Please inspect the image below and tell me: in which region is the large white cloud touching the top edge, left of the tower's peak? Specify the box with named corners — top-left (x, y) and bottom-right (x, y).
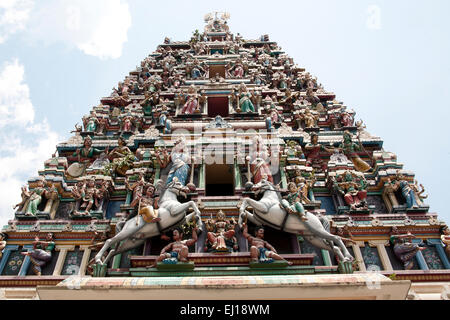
top-left (30, 0), bottom-right (131, 59)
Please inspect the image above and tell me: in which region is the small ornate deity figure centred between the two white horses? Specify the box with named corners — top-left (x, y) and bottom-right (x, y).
top-left (205, 210), bottom-right (238, 252)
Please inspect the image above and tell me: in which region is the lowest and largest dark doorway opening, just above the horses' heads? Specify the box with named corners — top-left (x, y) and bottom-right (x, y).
top-left (205, 164), bottom-right (234, 197)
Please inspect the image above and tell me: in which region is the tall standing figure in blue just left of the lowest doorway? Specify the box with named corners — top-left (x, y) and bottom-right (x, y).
top-left (166, 138), bottom-right (191, 186)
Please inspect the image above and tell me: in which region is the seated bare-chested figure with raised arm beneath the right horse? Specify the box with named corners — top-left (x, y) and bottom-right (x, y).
top-left (242, 223), bottom-right (292, 265)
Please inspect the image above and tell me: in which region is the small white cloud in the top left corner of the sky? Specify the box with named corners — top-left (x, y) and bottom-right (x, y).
top-left (0, 0), bottom-right (34, 44)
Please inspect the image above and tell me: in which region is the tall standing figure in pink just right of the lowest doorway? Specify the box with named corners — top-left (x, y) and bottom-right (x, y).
top-left (247, 135), bottom-right (274, 184)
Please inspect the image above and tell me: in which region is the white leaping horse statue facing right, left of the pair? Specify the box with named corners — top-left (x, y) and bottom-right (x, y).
top-left (95, 178), bottom-right (203, 265)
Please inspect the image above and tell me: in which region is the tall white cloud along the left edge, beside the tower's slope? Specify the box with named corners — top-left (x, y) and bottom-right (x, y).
top-left (0, 60), bottom-right (60, 227)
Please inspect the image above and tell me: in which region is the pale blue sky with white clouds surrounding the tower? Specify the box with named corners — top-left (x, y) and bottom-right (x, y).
top-left (0, 0), bottom-right (450, 225)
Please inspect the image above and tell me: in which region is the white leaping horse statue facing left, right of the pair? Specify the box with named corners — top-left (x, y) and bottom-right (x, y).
top-left (239, 179), bottom-right (353, 262)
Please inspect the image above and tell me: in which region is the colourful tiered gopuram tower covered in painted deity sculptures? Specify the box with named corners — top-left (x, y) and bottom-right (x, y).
top-left (0, 12), bottom-right (450, 300)
